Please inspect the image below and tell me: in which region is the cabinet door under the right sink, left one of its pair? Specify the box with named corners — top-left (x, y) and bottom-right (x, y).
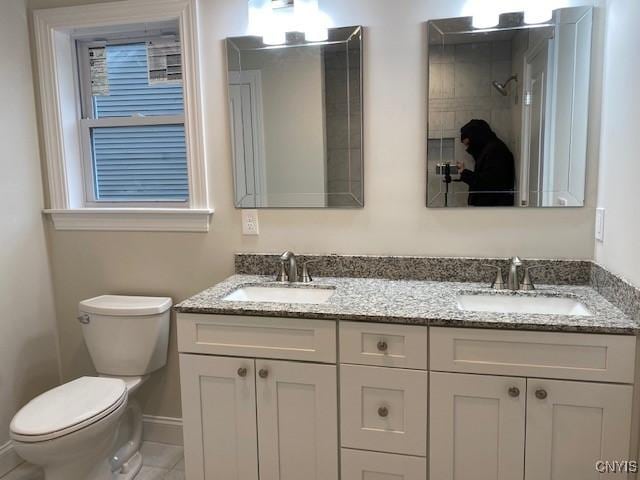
top-left (429, 372), bottom-right (526, 480)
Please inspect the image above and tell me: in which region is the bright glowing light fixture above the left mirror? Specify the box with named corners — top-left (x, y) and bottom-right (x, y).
top-left (248, 0), bottom-right (331, 45)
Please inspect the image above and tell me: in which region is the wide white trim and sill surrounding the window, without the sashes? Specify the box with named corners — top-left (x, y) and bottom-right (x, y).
top-left (33, 0), bottom-right (213, 232)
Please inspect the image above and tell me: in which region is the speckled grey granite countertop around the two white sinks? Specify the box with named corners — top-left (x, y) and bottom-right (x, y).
top-left (175, 275), bottom-right (640, 335)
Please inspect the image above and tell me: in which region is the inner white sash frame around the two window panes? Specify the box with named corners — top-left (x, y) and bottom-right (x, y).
top-left (76, 36), bottom-right (191, 208)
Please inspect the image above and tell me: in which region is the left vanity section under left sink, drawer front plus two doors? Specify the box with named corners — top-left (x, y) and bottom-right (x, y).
top-left (178, 314), bottom-right (339, 480)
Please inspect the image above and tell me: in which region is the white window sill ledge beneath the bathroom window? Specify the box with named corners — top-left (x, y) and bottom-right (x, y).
top-left (44, 208), bottom-right (213, 232)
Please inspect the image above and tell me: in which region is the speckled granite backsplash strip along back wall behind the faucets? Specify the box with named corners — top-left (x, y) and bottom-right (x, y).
top-left (235, 253), bottom-right (592, 285)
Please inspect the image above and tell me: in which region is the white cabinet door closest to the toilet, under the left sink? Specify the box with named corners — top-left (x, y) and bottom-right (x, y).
top-left (180, 354), bottom-right (258, 480)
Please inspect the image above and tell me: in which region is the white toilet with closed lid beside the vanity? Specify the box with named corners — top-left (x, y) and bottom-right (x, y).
top-left (10, 295), bottom-right (172, 480)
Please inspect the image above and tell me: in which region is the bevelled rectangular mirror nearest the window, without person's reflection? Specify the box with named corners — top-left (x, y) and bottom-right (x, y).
top-left (227, 27), bottom-right (364, 208)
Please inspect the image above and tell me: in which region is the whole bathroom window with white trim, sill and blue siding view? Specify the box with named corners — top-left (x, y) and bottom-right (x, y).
top-left (34, 0), bottom-right (213, 232)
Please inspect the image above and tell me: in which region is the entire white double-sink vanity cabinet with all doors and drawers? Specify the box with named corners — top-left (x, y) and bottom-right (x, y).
top-left (178, 313), bottom-right (640, 480)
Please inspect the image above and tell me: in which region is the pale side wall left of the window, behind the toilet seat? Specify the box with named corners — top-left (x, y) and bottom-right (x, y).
top-left (0, 0), bottom-right (59, 458)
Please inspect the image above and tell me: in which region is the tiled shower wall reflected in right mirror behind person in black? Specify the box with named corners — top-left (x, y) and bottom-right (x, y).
top-left (428, 41), bottom-right (516, 206)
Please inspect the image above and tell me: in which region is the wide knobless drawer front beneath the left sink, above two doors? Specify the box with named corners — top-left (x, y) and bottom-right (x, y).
top-left (178, 313), bottom-right (336, 363)
